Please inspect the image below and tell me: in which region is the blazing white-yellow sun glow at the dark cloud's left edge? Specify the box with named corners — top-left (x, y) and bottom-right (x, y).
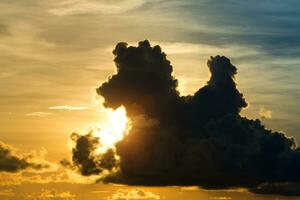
top-left (94, 106), bottom-right (130, 153)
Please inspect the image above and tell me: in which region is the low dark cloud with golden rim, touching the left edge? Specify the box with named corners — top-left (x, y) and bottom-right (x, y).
top-left (0, 142), bottom-right (49, 172)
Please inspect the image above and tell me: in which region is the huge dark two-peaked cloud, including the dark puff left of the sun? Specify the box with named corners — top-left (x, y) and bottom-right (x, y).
top-left (69, 41), bottom-right (300, 192)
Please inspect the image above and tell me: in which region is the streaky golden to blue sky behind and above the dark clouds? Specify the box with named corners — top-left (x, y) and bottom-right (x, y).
top-left (0, 0), bottom-right (300, 199)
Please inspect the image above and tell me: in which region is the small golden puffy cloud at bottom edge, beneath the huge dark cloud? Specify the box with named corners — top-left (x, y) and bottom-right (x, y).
top-left (108, 189), bottom-right (160, 200)
